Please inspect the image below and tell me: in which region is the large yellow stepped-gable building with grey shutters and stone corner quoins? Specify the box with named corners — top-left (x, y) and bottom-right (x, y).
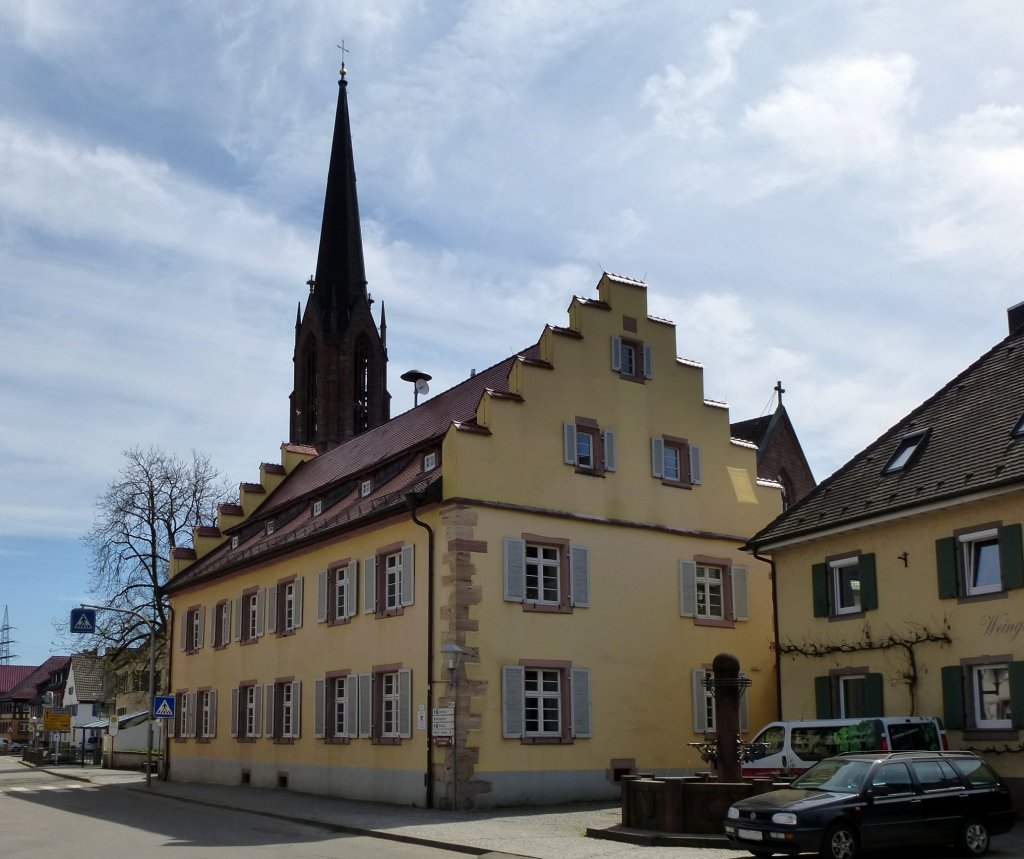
top-left (161, 274), bottom-right (781, 807)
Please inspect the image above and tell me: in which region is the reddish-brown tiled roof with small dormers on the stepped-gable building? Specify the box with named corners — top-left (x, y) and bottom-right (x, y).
top-left (165, 345), bottom-right (545, 592)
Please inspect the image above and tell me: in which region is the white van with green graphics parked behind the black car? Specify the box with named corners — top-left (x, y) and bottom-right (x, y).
top-left (741, 716), bottom-right (947, 778)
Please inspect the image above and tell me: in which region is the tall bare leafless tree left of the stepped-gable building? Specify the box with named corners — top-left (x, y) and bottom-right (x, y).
top-left (83, 446), bottom-right (233, 655)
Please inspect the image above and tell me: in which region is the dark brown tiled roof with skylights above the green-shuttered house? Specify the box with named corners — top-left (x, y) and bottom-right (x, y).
top-left (749, 328), bottom-right (1024, 550)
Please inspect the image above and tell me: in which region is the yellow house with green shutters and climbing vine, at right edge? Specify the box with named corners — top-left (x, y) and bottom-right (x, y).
top-left (748, 305), bottom-right (1024, 798)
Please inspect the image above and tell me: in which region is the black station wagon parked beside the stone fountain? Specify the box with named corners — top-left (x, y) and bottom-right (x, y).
top-left (725, 751), bottom-right (1017, 859)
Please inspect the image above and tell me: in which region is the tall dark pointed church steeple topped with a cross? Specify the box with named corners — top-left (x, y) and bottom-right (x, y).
top-left (289, 65), bottom-right (390, 453)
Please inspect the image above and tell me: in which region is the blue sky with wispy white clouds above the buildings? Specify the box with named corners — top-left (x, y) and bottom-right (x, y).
top-left (0, 0), bottom-right (1024, 664)
